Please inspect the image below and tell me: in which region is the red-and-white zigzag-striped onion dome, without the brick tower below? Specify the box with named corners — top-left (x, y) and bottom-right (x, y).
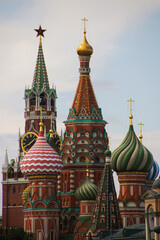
top-left (21, 125), bottom-right (63, 176)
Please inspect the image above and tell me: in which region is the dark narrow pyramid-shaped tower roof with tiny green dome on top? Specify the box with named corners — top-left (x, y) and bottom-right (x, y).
top-left (87, 148), bottom-right (122, 239)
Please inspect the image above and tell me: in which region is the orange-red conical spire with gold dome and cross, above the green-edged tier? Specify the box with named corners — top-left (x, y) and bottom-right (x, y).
top-left (68, 18), bottom-right (103, 120)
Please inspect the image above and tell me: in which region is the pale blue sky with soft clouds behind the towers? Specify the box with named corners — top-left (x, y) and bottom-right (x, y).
top-left (0, 0), bottom-right (160, 216)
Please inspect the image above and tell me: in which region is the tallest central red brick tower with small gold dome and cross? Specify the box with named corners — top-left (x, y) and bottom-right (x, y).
top-left (58, 19), bottom-right (107, 232)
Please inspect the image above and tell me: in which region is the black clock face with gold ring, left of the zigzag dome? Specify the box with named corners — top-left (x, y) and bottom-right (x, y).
top-left (21, 132), bottom-right (38, 153)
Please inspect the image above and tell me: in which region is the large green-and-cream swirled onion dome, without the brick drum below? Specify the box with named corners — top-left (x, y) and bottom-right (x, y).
top-left (111, 125), bottom-right (153, 172)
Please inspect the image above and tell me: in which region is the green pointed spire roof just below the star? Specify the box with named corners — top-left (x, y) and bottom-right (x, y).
top-left (32, 41), bottom-right (50, 95)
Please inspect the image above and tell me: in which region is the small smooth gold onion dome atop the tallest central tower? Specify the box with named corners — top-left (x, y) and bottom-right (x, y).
top-left (77, 32), bottom-right (93, 56)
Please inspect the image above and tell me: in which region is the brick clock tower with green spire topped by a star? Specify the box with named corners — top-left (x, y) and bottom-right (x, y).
top-left (2, 26), bottom-right (57, 229)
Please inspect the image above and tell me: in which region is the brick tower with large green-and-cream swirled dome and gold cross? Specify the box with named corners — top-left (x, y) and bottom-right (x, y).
top-left (111, 99), bottom-right (153, 227)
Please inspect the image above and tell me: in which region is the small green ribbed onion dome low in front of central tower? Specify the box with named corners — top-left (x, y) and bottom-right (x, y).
top-left (75, 172), bottom-right (98, 201)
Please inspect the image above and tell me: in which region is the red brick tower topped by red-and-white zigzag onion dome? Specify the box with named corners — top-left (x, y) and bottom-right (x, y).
top-left (21, 122), bottom-right (63, 240)
